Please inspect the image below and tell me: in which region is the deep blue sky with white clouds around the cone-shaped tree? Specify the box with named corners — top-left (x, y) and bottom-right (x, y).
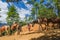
top-left (0, 0), bottom-right (32, 22)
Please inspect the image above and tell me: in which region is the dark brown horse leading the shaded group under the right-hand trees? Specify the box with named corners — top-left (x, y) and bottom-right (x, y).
top-left (32, 18), bottom-right (47, 31)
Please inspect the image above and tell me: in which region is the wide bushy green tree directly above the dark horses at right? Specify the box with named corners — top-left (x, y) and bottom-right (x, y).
top-left (38, 0), bottom-right (57, 18)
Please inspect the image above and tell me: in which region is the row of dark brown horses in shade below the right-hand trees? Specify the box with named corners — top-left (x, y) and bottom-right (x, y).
top-left (32, 17), bottom-right (60, 30)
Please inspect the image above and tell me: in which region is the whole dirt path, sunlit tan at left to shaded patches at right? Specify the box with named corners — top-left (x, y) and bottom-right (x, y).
top-left (0, 30), bottom-right (60, 40)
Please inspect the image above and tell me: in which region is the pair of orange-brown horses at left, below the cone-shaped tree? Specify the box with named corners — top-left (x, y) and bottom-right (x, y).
top-left (0, 22), bottom-right (20, 36)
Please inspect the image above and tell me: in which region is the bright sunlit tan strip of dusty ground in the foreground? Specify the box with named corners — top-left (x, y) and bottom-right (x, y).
top-left (0, 33), bottom-right (44, 40)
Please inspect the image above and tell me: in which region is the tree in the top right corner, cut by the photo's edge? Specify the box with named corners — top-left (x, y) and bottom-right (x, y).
top-left (47, 0), bottom-right (60, 17)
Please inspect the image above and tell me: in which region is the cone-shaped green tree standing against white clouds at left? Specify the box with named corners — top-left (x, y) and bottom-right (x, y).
top-left (6, 5), bottom-right (19, 25)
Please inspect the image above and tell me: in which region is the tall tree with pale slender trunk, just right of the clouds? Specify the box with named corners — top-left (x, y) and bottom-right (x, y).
top-left (27, 0), bottom-right (39, 20)
